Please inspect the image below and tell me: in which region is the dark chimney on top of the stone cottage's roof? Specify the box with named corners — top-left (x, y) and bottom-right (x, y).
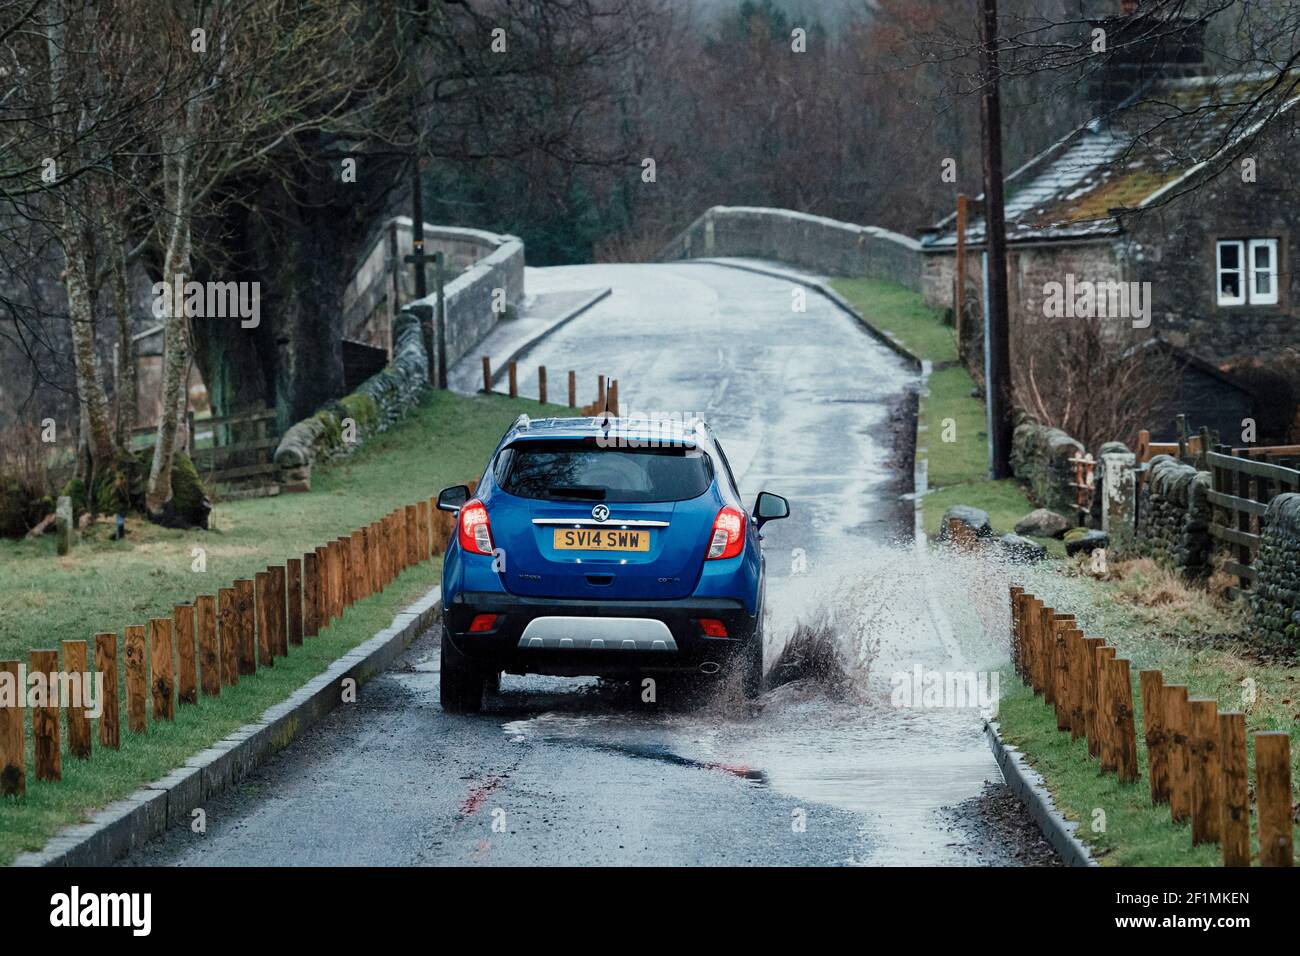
top-left (1088, 0), bottom-right (1205, 112)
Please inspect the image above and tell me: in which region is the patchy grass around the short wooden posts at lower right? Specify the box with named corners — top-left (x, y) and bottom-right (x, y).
top-left (998, 561), bottom-right (1300, 866)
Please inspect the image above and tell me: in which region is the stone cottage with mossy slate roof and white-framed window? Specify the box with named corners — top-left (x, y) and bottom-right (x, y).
top-left (922, 43), bottom-right (1300, 444)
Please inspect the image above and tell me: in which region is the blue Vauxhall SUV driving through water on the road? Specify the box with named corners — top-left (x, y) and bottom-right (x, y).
top-left (438, 415), bottom-right (789, 713)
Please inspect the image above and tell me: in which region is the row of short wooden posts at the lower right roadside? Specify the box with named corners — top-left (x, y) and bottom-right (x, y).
top-left (1011, 585), bottom-right (1294, 866)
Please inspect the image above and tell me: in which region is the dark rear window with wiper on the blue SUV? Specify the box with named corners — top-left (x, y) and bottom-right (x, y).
top-left (495, 441), bottom-right (714, 502)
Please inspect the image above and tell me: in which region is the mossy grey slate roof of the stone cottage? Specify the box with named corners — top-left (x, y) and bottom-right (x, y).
top-left (922, 73), bottom-right (1300, 251)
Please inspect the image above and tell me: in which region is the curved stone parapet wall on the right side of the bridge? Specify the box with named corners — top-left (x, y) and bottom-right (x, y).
top-left (658, 206), bottom-right (922, 291)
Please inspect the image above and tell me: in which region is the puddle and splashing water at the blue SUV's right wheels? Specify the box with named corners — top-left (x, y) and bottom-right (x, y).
top-left (493, 548), bottom-right (1024, 865)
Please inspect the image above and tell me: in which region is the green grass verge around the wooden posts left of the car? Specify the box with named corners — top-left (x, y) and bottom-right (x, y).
top-left (0, 393), bottom-right (567, 865)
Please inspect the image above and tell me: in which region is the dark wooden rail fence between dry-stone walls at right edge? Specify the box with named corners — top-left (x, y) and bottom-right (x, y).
top-left (1205, 445), bottom-right (1300, 597)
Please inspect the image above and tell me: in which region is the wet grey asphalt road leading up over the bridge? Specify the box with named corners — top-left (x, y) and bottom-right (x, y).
top-left (129, 264), bottom-right (1034, 865)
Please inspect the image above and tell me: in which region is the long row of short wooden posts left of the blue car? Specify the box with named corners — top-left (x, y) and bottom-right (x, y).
top-left (0, 481), bottom-right (477, 797)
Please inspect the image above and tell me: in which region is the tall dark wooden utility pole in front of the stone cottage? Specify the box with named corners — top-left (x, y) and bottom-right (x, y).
top-left (980, 0), bottom-right (1014, 479)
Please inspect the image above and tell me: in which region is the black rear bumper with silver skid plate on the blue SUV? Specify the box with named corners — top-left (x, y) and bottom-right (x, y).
top-left (443, 592), bottom-right (758, 676)
